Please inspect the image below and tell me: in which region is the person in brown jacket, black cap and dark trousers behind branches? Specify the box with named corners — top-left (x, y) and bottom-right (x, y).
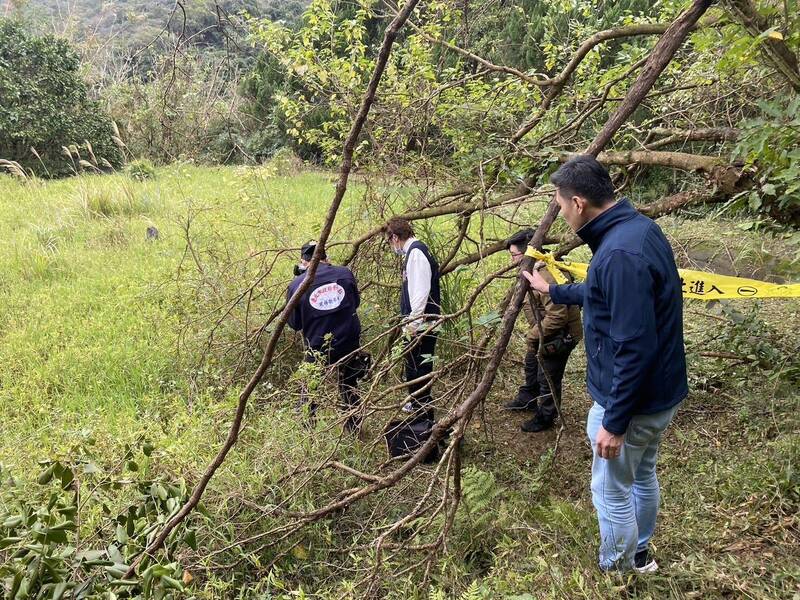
top-left (505, 229), bottom-right (583, 433)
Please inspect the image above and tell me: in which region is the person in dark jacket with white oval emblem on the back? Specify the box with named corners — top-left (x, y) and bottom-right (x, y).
top-left (287, 242), bottom-right (361, 431)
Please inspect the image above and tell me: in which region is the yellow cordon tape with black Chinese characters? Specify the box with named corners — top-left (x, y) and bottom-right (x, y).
top-left (525, 247), bottom-right (800, 300)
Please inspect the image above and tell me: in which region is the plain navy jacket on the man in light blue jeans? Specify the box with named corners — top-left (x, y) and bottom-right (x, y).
top-left (550, 199), bottom-right (689, 435)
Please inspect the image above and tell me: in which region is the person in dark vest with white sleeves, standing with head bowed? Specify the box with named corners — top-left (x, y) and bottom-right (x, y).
top-left (384, 218), bottom-right (442, 421)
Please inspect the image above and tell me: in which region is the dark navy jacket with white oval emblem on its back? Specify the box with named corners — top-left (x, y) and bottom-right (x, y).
top-left (286, 263), bottom-right (361, 355)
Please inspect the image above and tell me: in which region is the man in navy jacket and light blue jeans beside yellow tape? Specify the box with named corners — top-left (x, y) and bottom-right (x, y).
top-left (523, 156), bottom-right (688, 572)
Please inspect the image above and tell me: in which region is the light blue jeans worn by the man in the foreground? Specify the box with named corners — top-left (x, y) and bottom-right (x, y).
top-left (586, 402), bottom-right (680, 571)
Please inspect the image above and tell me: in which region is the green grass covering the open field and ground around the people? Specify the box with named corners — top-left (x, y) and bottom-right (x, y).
top-left (0, 166), bottom-right (800, 598)
